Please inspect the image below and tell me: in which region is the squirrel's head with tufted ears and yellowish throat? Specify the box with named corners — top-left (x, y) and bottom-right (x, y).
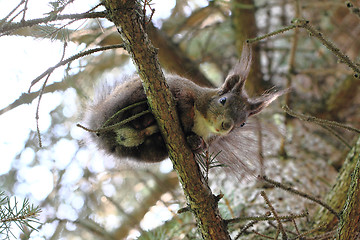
top-left (195, 46), bottom-right (287, 139)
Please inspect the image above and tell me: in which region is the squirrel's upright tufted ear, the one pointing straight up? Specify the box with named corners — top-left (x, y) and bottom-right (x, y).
top-left (220, 44), bottom-right (252, 93)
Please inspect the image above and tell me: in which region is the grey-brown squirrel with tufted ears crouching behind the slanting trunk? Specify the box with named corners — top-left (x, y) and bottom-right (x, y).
top-left (82, 47), bottom-right (286, 162)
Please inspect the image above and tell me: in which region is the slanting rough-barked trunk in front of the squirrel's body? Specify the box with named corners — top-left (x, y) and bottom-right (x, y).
top-left (105, 0), bottom-right (230, 239)
